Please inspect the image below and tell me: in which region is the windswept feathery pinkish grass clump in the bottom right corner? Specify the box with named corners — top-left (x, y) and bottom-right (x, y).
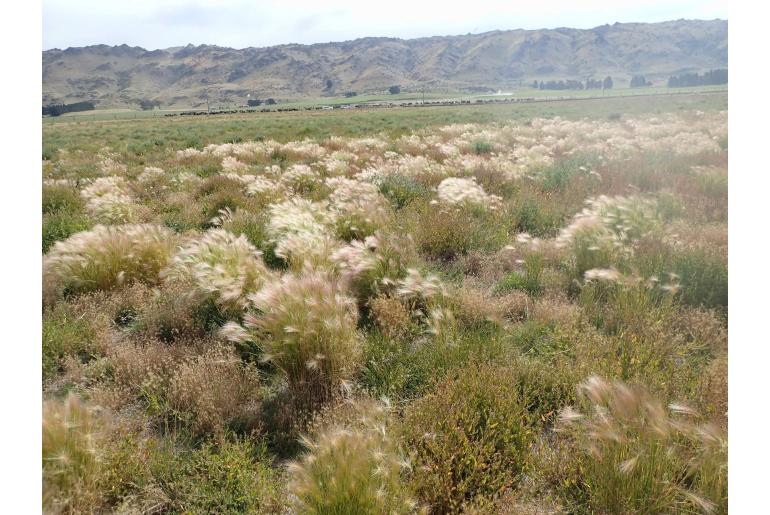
top-left (560, 377), bottom-right (727, 514)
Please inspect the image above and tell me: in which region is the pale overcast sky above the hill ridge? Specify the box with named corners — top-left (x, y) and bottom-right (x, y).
top-left (43, 0), bottom-right (727, 50)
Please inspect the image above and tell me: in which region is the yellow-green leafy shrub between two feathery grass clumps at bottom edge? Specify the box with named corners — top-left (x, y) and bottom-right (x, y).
top-left (403, 365), bottom-right (531, 513)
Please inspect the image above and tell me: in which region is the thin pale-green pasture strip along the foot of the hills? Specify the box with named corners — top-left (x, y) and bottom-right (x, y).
top-left (43, 86), bottom-right (727, 123)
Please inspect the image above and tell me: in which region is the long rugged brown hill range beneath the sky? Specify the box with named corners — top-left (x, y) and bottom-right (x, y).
top-left (42, 20), bottom-right (727, 107)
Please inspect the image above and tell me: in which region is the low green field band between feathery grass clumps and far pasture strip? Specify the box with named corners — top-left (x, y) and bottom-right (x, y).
top-left (43, 91), bottom-right (727, 161)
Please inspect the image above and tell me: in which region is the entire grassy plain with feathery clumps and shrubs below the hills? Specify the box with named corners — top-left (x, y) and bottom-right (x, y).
top-left (41, 90), bottom-right (729, 515)
